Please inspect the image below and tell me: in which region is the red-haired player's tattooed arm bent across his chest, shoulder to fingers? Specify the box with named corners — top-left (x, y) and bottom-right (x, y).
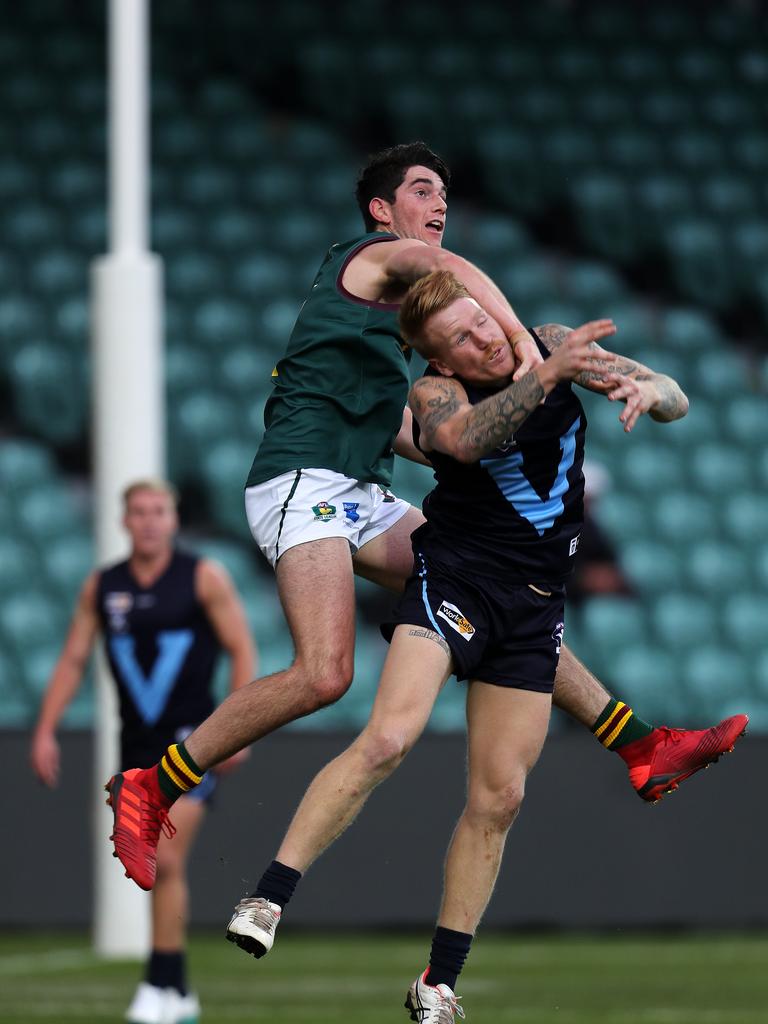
top-left (409, 321), bottom-right (616, 462)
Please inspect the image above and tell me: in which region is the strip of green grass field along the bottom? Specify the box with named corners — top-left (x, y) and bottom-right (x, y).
top-left (0, 932), bottom-right (768, 1024)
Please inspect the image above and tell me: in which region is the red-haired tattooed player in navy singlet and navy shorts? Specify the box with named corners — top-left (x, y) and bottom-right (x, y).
top-left (227, 271), bottom-right (746, 1024)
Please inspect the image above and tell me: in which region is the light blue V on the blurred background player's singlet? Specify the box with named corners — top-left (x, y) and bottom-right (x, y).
top-left (110, 630), bottom-right (195, 725)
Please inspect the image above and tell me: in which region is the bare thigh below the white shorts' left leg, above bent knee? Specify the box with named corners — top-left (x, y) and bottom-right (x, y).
top-left (275, 537), bottom-right (354, 658)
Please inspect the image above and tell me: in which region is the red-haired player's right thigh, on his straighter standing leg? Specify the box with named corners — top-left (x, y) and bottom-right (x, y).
top-left (467, 680), bottom-right (552, 792)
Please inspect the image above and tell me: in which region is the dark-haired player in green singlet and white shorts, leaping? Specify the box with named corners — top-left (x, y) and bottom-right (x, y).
top-left (110, 142), bottom-right (749, 905)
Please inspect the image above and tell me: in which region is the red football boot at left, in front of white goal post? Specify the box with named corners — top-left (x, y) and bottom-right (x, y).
top-left (104, 768), bottom-right (176, 890)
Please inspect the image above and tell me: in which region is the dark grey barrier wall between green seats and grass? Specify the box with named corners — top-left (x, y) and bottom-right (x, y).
top-left (0, 732), bottom-right (768, 928)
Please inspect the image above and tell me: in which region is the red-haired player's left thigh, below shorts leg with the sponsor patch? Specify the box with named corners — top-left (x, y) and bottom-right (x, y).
top-left (367, 625), bottom-right (452, 743)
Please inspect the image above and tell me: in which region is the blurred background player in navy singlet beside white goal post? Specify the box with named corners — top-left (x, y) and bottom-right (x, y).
top-left (32, 480), bottom-right (255, 1024)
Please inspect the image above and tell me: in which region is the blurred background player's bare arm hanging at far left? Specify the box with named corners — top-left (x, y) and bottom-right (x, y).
top-left (30, 572), bottom-right (98, 786)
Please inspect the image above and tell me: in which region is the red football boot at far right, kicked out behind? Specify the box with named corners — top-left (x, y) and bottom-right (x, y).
top-left (616, 715), bottom-right (750, 804)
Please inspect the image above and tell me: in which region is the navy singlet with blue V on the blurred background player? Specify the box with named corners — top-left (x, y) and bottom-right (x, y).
top-left (96, 551), bottom-right (220, 754)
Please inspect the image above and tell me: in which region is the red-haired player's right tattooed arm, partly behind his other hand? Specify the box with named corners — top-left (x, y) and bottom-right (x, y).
top-left (536, 324), bottom-right (688, 433)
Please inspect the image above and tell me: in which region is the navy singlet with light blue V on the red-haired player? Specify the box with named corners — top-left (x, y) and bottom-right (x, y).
top-left (414, 338), bottom-right (587, 583)
